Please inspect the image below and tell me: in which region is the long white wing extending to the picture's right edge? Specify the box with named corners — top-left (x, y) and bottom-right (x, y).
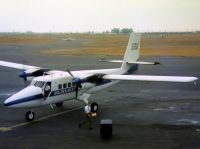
top-left (102, 75), bottom-right (198, 82)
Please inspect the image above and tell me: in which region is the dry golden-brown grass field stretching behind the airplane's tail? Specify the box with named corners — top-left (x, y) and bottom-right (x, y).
top-left (0, 33), bottom-right (200, 56)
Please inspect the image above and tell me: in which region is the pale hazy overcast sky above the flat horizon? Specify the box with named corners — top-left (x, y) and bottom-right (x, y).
top-left (0, 0), bottom-right (200, 32)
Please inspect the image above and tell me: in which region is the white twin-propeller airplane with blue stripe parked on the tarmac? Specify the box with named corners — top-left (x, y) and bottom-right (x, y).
top-left (0, 33), bottom-right (198, 121)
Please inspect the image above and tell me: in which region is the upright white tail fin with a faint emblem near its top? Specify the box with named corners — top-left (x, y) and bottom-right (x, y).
top-left (121, 32), bottom-right (140, 71)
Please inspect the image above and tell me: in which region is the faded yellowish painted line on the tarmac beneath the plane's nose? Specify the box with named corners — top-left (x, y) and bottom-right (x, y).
top-left (0, 106), bottom-right (83, 132)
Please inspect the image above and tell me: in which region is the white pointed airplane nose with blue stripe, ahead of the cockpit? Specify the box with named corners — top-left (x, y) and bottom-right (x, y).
top-left (4, 86), bottom-right (43, 107)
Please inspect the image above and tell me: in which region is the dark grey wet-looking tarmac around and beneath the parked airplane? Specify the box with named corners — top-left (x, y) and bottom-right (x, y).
top-left (0, 41), bottom-right (200, 149)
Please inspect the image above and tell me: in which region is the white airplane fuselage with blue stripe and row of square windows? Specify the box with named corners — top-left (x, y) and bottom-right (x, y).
top-left (4, 69), bottom-right (121, 108)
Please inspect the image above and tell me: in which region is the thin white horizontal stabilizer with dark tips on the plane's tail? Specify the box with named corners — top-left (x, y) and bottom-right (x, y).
top-left (99, 59), bottom-right (160, 65)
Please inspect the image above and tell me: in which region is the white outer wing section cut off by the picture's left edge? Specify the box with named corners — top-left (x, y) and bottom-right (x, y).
top-left (0, 61), bottom-right (40, 70)
